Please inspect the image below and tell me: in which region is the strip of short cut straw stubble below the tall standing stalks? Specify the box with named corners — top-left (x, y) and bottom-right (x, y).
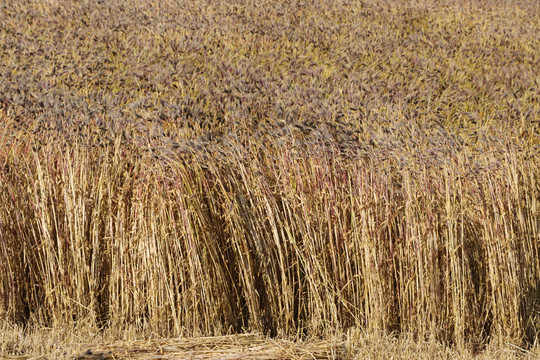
top-left (2, 326), bottom-right (540, 360)
